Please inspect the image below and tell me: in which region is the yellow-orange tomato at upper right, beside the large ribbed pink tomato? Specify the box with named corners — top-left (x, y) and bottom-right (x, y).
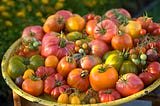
top-left (119, 20), bottom-right (142, 39)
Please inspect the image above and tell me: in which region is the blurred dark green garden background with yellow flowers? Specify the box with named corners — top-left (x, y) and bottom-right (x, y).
top-left (0, 0), bottom-right (160, 102)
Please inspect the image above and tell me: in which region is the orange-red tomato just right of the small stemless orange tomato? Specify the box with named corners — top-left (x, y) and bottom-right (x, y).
top-left (57, 56), bottom-right (77, 77)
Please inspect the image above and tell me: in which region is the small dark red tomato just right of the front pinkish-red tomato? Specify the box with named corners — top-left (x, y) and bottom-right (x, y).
top-left (139, 72), bottom-right (156, 85)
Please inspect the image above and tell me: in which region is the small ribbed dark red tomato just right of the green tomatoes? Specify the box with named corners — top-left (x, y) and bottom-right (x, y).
top-left (35, 66), bottom-right (56, 79)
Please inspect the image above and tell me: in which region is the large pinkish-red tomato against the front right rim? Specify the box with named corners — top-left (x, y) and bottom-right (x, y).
top-left (116, 73), bottom-right (144, 97)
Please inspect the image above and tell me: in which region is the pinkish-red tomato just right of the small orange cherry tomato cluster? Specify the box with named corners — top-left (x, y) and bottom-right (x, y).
top-left (89, 39), bottom-right (109, 57)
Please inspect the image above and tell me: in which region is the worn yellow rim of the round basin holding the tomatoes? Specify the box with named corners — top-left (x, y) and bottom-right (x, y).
top-left (1, 38), bottom-right (160, 106)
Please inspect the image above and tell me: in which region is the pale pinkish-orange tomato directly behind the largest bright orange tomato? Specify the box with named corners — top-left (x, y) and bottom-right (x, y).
top-left (80, 55), bottom-right (102, 71)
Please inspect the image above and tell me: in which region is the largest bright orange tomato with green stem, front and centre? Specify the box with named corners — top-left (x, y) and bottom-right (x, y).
top-left (89, 64), bottom-right (118, 91)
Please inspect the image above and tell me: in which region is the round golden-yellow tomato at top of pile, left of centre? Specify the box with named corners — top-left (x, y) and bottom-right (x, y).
top-left (65, 15), bottom-right (85, 32)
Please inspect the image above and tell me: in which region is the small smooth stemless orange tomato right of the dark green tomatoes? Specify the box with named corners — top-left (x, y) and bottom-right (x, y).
top-left (45, 55), bottom-right (59, 68)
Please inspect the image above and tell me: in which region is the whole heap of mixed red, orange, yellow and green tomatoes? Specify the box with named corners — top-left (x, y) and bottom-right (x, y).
top-left (7, 8), bottom-right (160, 104)
